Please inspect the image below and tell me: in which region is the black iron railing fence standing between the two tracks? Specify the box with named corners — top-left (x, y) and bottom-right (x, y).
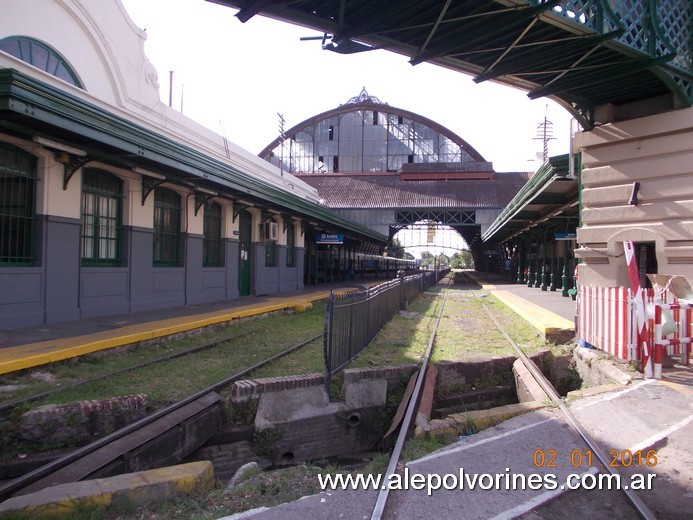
top-left (323, 269), bottom-right (449, 390)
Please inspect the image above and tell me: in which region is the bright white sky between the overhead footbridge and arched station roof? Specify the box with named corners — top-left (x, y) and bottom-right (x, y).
top-left (121, 0), bottom-right (571, 171)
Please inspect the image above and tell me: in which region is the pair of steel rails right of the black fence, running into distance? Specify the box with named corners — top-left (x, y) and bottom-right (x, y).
top-left (371, 273), bottom-right (656, 520)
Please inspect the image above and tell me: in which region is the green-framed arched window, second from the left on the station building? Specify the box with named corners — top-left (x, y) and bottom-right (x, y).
top-left (81, 168), bottom-right (123, 267)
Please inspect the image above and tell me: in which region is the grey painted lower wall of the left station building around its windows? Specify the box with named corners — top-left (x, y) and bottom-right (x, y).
top-left (0, 229), bottom-right (305, 328)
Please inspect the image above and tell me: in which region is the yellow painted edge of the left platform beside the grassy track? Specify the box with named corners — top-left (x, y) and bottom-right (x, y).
top-left (0, 291), bottom-right (330, 374)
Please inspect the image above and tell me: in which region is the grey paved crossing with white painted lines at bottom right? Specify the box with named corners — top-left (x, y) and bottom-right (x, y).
top-left (224, 370), bottom-right (693, 520)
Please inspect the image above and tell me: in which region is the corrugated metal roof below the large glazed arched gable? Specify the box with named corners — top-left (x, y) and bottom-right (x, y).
top-left (297, 172), bottom-right (532, 209)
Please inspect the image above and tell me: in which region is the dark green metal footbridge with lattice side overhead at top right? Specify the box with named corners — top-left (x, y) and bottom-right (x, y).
top-left (209, 0), bottom-right (693, 128)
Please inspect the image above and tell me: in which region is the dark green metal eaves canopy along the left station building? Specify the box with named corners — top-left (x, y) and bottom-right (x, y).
top-left (0, 69), bottom-right (387, 244)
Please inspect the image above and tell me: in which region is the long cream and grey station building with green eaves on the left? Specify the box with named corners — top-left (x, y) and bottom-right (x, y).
top-left (0, 0), bottom-right (387, 328)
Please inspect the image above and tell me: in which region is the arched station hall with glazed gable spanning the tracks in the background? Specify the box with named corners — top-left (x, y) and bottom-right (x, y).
top-left (259, 87), bottom-right (531, 266)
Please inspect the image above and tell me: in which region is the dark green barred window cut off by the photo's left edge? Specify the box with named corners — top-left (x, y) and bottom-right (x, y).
top-left (0, 143), bottom-right (36, 267)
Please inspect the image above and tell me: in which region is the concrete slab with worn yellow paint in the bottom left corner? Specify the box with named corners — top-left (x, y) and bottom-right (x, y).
top-left (0, 461), bottom-right (214, 517)
